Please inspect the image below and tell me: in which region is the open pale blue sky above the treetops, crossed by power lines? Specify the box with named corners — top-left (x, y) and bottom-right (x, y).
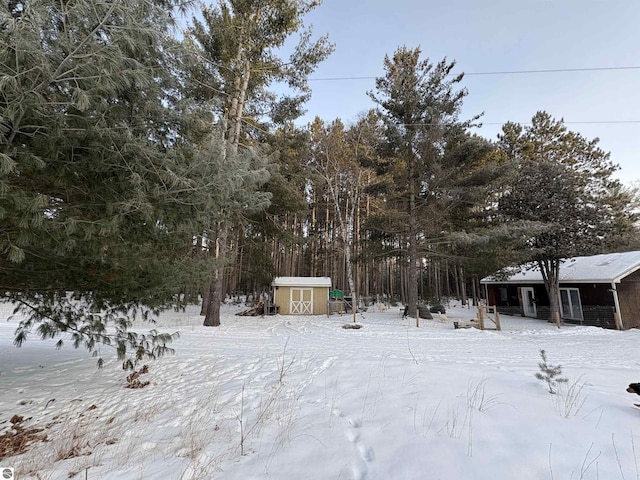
top-left (300, 0), bottom-right (640, 185)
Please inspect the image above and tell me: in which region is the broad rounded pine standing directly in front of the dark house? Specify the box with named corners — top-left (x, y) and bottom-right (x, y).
top-left (497, 112), bottom-right (636, 326)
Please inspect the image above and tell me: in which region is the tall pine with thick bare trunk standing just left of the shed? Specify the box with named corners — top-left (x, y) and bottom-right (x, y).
top-left (187, 0), bottom-right (333, 326)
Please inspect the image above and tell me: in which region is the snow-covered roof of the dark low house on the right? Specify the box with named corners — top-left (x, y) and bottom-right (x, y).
top-left (480, 251), bottom-right (640, 283)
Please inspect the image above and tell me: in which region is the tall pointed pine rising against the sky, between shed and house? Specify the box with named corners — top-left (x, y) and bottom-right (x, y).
top-left (369, 48), bottom-right (478, 317)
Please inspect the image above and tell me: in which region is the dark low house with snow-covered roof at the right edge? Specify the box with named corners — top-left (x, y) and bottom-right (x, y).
top-left (480, 252), bottom-right (640, 329)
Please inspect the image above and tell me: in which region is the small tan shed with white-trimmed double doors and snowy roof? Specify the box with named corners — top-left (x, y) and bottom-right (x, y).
top-left (271, 277), bottom-right (331, 315)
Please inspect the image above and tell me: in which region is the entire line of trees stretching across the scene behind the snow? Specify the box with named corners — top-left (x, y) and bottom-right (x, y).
top-left (0, 0), bottom-right (637, 360)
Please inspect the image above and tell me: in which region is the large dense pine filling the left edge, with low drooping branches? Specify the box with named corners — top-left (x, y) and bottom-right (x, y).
top-left (0, 0), bottom-right (226, 364)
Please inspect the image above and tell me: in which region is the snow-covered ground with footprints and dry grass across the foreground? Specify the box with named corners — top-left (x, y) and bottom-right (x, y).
top-left (0, 306), bottom-right (640, 480)
